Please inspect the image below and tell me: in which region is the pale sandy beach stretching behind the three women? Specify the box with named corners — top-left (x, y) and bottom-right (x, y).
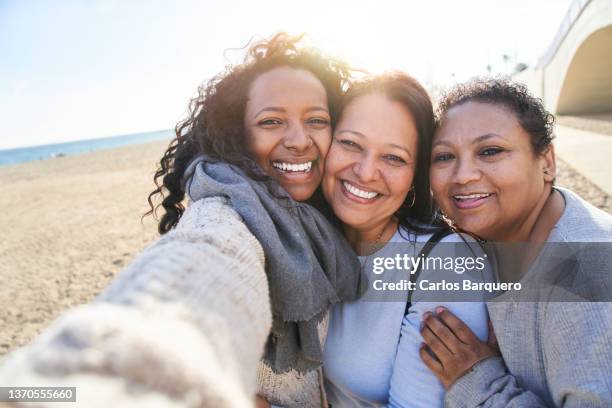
top-left (0, 142), bottom-right (612, 355)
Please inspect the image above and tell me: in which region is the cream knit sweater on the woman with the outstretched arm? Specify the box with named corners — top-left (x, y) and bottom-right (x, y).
top-left (0, 198), bottom-right (325, 408)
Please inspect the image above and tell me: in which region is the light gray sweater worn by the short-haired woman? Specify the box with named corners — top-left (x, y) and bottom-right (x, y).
top-left (446, 189), bottom-right (612, 408)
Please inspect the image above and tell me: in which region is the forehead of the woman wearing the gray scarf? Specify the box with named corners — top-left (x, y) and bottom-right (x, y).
top-left (247, 66), bottom-right (327, 108)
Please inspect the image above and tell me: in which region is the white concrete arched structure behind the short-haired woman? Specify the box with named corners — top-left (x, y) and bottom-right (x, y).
top-left (514, 0), bottom-right (612, 115)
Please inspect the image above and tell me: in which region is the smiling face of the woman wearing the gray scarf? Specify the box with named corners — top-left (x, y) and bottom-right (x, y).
top-left (244, 67), bottom-right (331, 201)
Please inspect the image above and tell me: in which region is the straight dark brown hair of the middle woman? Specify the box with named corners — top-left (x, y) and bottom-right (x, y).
top-left (342, 71), bottom-right (436, 232)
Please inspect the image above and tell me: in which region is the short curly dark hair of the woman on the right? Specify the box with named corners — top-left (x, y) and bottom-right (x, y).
top-left (437, 78), bottom-right (555, 153)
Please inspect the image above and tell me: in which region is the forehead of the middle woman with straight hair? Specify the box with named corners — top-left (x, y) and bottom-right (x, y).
top-left (337, 93), bottom-right (417, 145)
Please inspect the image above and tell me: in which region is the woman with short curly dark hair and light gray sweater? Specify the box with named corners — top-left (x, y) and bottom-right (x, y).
top-left (421, 79), bottom-right (612, 407)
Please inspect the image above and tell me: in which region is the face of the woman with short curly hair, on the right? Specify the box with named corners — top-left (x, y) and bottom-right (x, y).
top-left (430, 102), bottom-right (554, 241)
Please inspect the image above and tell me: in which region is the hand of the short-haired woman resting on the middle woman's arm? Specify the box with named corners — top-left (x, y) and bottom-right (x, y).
top-left (419, 307), bottom-right (501, 390)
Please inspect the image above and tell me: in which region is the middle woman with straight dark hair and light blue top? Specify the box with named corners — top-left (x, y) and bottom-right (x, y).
top-left (323, 72), bottom-right (486, 408)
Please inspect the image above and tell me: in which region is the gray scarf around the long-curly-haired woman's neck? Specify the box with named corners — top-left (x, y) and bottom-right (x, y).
top-left (184, 156), bottom-right (363, 373)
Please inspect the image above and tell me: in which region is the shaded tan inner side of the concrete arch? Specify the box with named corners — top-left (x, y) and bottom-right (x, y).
top-left (556, 25), bottom-right (612, 115)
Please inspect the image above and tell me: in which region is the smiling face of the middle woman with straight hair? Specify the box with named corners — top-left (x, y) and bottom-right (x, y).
top-left (323, 93), bottom-right (418, 231)
